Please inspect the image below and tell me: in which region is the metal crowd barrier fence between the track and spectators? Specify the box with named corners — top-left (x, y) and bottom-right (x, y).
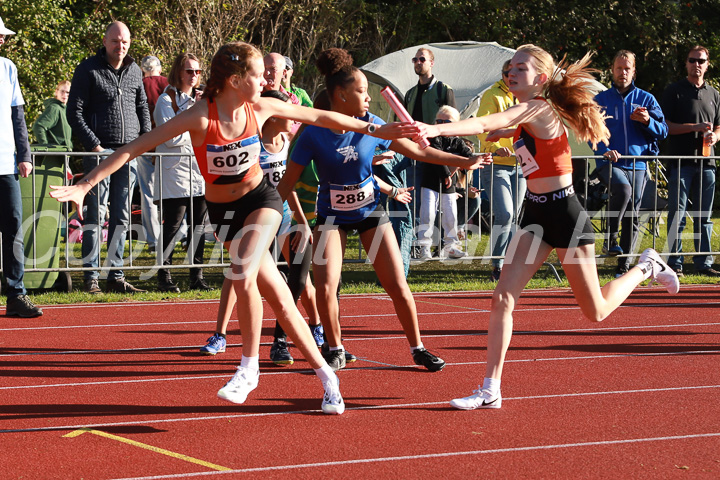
top-left (1, 152), bottom-right (720, 290)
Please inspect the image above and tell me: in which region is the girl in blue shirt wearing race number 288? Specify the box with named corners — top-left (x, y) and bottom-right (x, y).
top-left (278, 48), bottom-right (483, 371)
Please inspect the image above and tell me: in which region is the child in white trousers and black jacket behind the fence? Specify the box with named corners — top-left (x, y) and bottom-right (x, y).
top-left (418, 105), bottom-right (472, 260)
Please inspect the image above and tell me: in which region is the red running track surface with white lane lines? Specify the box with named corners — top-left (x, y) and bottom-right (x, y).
top-left (0, 286), bottom-right (720, 479)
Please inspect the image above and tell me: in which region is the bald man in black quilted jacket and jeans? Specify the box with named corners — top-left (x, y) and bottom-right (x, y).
top-left (67, 22), bottom-right (150, 293)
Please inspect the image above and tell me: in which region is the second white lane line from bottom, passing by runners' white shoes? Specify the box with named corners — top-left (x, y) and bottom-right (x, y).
top-left (0, 385), bottom-right (720, 434)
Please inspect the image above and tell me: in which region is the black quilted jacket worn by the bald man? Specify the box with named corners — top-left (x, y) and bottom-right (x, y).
top-left (67, 47), bottom-right (150, 151)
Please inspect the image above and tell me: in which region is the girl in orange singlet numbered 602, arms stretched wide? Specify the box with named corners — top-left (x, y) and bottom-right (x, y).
top-left (51, 42), bottom-right (428, 414)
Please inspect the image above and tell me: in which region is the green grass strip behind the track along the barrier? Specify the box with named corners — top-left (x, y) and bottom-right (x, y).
top-left (11, 212), bottom-right (720, 305)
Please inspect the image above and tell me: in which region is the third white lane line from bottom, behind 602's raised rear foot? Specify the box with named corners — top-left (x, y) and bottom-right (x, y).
top-left (0, 350), bottom-right (718, 392)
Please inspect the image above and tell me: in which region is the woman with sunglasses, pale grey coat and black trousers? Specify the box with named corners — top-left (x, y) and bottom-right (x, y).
top-left (154, 53), bottom-right (211, 293)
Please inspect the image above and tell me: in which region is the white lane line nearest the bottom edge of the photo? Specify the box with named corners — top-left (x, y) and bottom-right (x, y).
top-left (109, 432), bottom-right (720, 480)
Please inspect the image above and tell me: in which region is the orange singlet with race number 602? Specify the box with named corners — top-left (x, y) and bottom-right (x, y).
top-left (193, 100), bottom-right (262, 185)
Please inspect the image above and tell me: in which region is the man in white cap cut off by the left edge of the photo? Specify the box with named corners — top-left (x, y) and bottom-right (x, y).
top-left (0, 19), bottom-right (42, 317)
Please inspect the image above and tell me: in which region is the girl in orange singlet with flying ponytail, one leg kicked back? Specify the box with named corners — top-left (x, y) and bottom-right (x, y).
top-left (424, 45), bottom-right (679, 410)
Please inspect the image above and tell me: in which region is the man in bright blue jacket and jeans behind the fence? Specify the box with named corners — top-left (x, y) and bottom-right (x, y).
top-left (595, 50), bottom-right (668, 276)
